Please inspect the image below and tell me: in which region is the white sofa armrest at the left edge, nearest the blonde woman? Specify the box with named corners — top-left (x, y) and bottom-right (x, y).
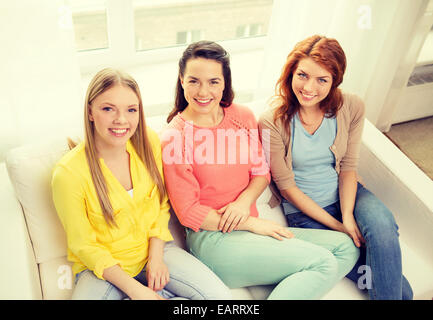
top-left (0, 162), bottom-right (42, 299)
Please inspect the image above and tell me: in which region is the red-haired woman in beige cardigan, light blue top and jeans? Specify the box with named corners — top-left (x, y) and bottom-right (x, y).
top-left (259, 35), bottom-right (413, 299)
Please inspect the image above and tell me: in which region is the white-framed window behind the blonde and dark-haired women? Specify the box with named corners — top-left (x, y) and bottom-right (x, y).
top-left (71, 0), bottom-right (273, 73)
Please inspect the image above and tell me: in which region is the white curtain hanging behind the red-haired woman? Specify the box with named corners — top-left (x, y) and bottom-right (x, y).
top-left (256, 0), bottom-right (428, 127)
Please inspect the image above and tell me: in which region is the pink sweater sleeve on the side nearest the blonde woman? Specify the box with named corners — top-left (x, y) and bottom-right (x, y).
top-left (162, 129), bottom-right (212, 232)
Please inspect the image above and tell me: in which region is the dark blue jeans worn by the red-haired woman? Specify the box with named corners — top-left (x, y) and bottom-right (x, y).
top-left (282, 183), bottom-right (413, 300)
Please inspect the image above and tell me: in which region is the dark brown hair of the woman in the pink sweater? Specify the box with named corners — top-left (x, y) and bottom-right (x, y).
top-left (167, 40), bottom-right (234, 122)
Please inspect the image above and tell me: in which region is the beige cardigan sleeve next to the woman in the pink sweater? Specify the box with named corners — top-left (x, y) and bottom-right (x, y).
top-left (259, 110), bottom-right (296, 190)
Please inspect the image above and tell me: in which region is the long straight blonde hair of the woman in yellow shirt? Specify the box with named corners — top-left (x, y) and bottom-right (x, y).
top-left (68, 68), bottom-right (166, 227)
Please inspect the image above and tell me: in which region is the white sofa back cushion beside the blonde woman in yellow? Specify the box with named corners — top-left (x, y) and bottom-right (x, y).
top-left (6, 139), bottom-right (68, 263)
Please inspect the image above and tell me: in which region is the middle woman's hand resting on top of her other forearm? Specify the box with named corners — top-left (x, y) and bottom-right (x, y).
top-left (217, 200), bottom-right (251, 232)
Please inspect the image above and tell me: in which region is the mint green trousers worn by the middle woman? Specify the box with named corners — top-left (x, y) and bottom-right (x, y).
top-left (187, 228), bottom-right (359, 300)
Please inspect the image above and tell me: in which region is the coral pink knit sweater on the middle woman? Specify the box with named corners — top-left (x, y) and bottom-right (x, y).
top-left (161, 104), bottom-right (270, 231)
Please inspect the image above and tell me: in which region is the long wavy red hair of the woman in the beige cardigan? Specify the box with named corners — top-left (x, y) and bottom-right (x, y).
top-left (274, 35), bottom-right (346, 128)
